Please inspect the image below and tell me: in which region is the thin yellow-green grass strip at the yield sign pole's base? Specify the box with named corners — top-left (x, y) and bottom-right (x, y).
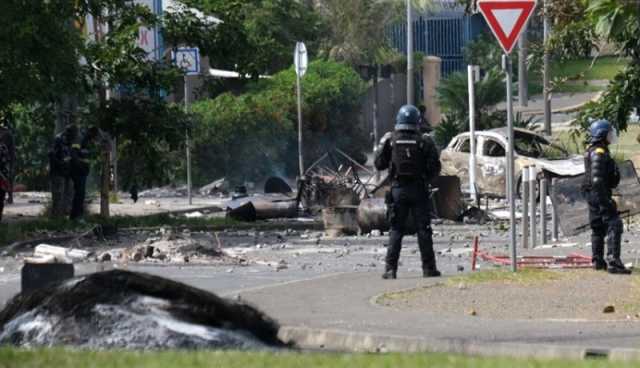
top-left (447, 268), bottom-right (568, 287)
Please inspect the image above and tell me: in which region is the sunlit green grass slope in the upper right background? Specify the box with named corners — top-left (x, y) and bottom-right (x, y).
top-left (551, 56), bottom-right (630, 80)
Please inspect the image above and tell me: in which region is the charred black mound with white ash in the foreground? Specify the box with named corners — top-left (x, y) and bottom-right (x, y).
top-left (0, 270), bottom-right (286, 350)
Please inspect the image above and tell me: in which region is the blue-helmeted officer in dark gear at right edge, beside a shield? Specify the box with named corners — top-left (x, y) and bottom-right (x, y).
top-left (583, 120), bottom-right (631, 274)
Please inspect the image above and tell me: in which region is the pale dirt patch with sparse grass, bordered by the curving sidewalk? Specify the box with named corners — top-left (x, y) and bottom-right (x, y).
top-left (377, 270), bottom-right (640, 321)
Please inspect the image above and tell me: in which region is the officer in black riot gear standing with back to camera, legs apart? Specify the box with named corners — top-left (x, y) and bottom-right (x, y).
top-left (375, 105), bottom-right (441, 279)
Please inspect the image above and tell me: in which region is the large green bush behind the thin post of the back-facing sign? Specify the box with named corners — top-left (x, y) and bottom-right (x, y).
top-left (193, 61), bottom-right (367, 187)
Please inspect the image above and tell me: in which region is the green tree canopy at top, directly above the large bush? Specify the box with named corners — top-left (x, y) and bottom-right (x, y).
top-left (175, 0), bottom-right (324, 79)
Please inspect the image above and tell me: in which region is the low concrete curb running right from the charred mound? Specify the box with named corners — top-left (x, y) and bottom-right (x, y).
top-left (278, 326), bottom-right (640, 361)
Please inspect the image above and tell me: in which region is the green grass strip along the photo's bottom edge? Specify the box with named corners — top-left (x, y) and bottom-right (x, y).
top-left (0, 348), bottom-right (637, 368)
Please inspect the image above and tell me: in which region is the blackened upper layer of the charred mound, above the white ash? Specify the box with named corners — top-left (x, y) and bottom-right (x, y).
top-left (0, 270), bottom-right (287, 348)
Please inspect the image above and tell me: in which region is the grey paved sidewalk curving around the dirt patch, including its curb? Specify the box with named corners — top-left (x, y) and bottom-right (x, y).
top-left (239, 273), bottom-right (640, 358)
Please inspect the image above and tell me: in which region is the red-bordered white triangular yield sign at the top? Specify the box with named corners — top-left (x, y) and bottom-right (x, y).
top-left (478, 0), bottom-right (536, 55)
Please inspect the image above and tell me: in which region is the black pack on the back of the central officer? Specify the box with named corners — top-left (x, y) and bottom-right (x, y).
top-left (391, 130), bottom-right (426, 179)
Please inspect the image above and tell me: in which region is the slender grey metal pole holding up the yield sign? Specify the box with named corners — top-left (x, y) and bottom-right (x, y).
top-left (502, 55), bottom-right (518, 272)
